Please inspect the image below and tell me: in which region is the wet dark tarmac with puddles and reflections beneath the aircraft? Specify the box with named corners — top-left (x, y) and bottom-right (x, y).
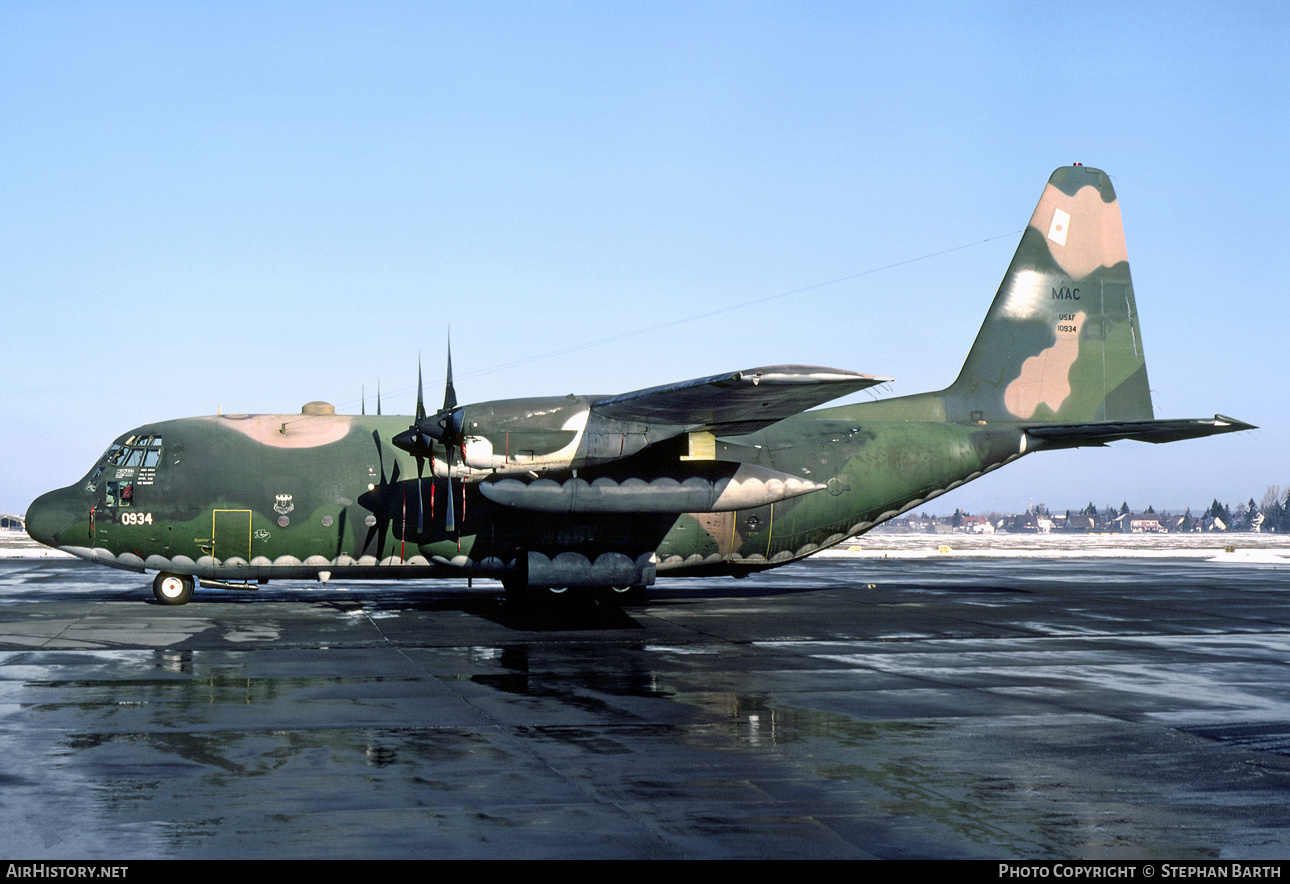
top-left (0, 559), bottom-right (1290, 858)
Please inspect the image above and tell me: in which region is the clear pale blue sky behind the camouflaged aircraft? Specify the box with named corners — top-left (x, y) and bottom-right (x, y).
top-left (0, 0), bottom-right (1290, 512)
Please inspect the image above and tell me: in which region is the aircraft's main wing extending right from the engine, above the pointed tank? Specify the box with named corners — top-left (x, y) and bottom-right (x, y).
top-left (591, 365), bottom-right (891, 436)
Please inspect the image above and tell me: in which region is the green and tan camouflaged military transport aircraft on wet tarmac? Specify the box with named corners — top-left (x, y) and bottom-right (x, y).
top-left (27, 165), bottom-right (1253, 604)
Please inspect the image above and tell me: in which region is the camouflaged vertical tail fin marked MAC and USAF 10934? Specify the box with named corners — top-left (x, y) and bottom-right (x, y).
top-left (944, 165), bottom-right (1152, 423)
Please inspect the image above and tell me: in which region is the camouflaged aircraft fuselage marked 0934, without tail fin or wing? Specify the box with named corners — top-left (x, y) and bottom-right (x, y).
top-left (25, 400), bottom-right (1033, 583)
